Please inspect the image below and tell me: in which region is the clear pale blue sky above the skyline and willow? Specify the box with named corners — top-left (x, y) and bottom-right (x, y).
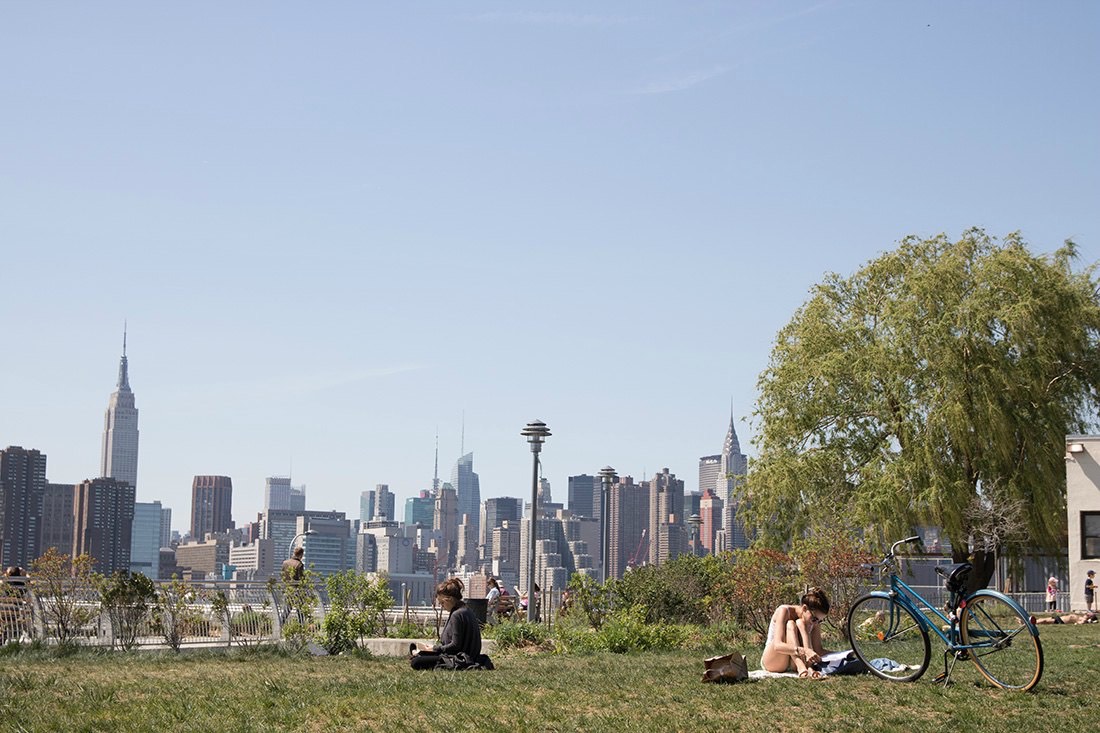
top-left (0, 0), bottom-right (1100, 528)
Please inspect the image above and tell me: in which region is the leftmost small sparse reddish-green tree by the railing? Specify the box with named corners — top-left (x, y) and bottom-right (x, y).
top-left (31, 547), bottom-right (99, 646)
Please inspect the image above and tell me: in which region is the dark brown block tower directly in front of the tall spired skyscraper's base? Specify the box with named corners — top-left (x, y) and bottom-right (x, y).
top-left (72, 478), bottom-right (134, 576)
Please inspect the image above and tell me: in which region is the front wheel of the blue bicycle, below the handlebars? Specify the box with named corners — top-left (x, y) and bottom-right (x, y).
top-left (848, 595), bottom-right (932, 682)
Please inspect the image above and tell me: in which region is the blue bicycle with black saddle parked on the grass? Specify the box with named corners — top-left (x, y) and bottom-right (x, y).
top-left (848, 537), bottom-right (1043, 690)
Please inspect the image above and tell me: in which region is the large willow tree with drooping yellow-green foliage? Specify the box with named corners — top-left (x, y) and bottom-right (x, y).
top-left (746, 229), bottom-right (1100, 584)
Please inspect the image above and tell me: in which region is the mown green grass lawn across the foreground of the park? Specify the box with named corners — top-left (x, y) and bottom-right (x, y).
top-left (0, 624), bottom-right (1100, 733)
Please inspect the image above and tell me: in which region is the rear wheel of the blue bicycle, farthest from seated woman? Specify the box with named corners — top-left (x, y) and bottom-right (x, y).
top-left (959, 590), bottom-right (1043, 690)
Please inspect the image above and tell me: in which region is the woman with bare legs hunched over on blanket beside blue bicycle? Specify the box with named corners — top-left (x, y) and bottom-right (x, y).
top-left (760, 588), bottom-right (828, 679)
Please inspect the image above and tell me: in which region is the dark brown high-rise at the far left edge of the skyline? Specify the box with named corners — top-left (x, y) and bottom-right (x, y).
top-left (0, 446), bottom-right (46, 568)
